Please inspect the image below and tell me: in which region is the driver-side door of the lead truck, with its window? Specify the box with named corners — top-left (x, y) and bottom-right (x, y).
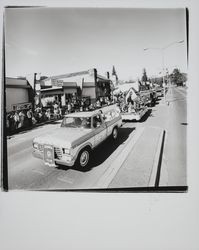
top-left (93, 114), bottom-right (106, 146)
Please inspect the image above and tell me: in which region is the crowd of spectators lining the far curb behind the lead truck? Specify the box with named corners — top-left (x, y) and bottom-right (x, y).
top-left (6, 97), bottom-right (114, 135)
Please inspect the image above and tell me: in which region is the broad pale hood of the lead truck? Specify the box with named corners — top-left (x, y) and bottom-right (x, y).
top-left (33, 128), bottom-right (93, 148)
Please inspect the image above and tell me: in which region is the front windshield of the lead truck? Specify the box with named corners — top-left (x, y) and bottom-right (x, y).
top-left (61, 117), bottom-right (91, 128)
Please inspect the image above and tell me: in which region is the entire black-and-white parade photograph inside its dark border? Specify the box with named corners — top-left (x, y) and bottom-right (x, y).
top-left (3, 7), bottom-right (189, 191)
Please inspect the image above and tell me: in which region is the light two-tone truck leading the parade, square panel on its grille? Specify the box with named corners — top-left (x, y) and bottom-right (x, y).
top-left (33, 105), bottom-right (122, 168)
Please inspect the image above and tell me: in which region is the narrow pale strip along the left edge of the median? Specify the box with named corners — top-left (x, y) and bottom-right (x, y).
top-left (94, 127), bottom-right (145, 188)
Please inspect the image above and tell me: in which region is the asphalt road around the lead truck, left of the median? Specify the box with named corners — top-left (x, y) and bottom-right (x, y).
top-left (8, 119), bottom-right (135, 190)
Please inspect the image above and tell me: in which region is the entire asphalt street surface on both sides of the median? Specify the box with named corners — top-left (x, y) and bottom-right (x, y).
top-left (7, 88), bottom-right (187, 190)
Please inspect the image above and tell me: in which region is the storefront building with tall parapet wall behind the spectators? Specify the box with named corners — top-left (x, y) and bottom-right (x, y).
top-left (40, 69), bottom-right (113, 106)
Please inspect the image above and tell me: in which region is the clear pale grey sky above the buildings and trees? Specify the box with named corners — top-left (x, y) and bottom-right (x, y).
top-left (5, 7), bottom-right (187, 80)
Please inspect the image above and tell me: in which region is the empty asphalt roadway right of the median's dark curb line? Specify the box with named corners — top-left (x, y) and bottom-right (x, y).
top-left (160, 87), bottom-right (188, 186)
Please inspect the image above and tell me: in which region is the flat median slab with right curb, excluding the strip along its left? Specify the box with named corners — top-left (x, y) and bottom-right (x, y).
top-left (108, 127), bottom-right (162, 188)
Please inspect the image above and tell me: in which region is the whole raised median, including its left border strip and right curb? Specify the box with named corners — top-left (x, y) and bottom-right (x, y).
top-left (97, 127), bottom-right (163, 188)
